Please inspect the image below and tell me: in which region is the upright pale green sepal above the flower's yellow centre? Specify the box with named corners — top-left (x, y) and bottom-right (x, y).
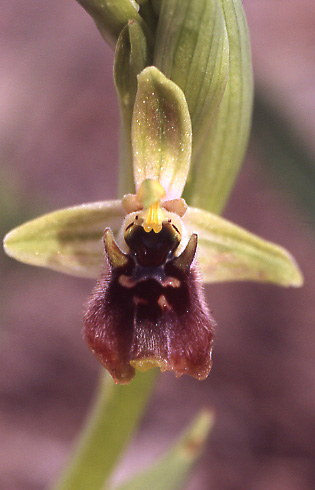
top-left (132, 66), bottom-right (191, 199)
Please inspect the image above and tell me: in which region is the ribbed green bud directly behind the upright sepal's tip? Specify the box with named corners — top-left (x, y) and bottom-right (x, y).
top-left (154, 0), bottom-right (229, 151)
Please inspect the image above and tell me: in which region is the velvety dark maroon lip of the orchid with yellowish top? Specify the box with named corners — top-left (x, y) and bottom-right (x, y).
top-left (85, 179), bottom-right (215, 383)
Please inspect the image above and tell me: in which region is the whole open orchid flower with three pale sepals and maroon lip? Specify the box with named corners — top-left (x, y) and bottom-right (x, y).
top-left (4, 66), bottom-right (302, 383)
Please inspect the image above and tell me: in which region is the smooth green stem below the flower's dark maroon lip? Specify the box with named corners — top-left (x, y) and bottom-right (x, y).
top-left (53, 369), bottom-right (158, 490)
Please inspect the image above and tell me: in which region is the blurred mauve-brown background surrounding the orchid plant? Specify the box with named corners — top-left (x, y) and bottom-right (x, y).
top-left (0, 0), bottom-right (315, 490)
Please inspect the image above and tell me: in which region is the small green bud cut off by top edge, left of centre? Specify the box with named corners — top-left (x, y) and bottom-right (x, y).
top-left (77, 0), bottom-right (152, 46)
